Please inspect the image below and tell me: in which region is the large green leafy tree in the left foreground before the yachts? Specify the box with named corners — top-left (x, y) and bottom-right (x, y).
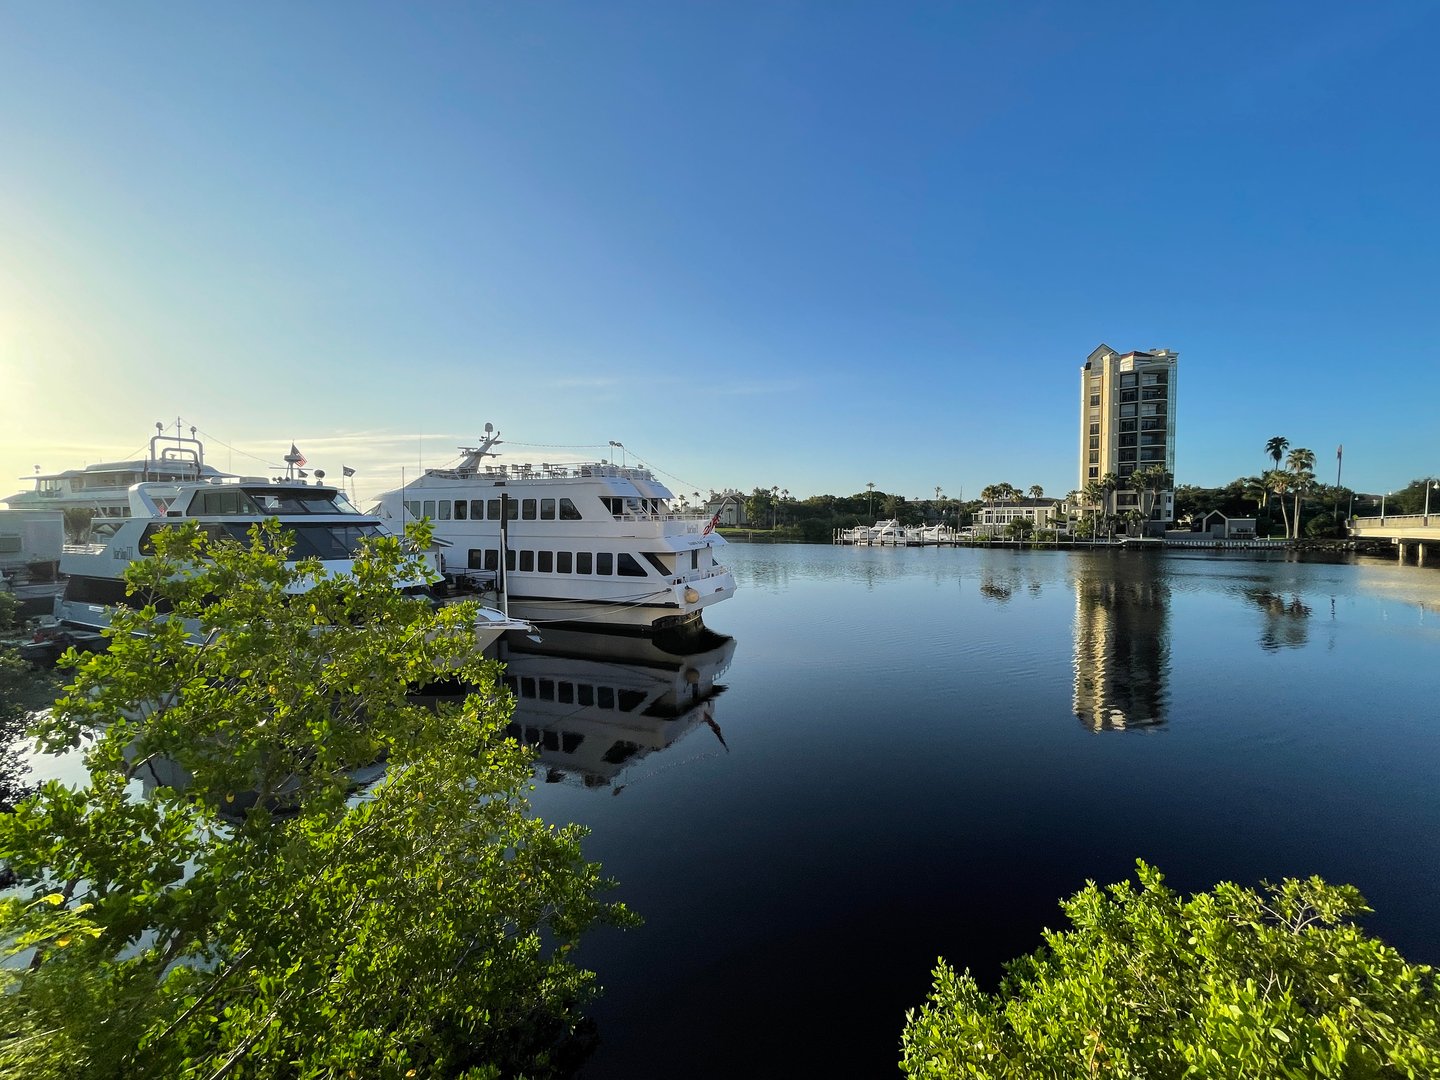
top-left (0, 530), bottom-right (629, 1077)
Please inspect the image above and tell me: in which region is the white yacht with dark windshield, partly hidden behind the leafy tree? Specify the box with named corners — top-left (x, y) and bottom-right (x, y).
top-left (32, 477), bottom-right (534, 665)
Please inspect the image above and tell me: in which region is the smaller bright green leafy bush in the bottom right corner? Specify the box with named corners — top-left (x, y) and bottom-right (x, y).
top-left (901, 863), bottom-right (1440, 1080)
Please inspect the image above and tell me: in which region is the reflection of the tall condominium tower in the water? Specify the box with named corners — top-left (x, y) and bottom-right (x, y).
top-left (1073, 557), bottom-right (1171, 732)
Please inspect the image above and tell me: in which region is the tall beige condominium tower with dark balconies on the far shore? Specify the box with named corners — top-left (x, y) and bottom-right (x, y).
top-left (1080, 344), bottom-right (1179, 531)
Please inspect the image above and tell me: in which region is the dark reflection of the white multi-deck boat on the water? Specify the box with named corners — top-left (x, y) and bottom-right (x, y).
top-left (498, 626), bottom-right (734, 795)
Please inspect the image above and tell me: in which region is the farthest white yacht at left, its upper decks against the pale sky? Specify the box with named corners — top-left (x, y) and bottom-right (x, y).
top-left (0, 422), bottom-right (228, 518)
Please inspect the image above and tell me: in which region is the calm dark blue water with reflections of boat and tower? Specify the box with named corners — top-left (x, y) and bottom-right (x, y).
top-left (513, 546), bottom-right (1440, 1080)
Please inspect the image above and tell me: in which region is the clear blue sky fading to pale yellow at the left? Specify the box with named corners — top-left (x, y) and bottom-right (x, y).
top-left (0, 0), bottom-right (1440, 497)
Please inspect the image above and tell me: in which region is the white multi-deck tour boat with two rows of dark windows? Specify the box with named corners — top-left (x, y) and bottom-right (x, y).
top-left (379, 423), bottom-right (734, 634)
